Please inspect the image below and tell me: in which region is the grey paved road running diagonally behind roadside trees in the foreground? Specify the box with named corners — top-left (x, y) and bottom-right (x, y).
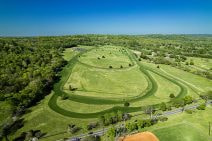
top-left (66, 100), bottom-right (212, 141)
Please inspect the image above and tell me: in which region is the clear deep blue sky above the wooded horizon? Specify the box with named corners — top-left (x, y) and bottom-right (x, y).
top-left (0, 0), bottom-right (212, 36)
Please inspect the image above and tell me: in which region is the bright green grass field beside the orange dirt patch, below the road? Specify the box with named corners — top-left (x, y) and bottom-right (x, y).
top-left (149, 107), bottom-right (212, 141)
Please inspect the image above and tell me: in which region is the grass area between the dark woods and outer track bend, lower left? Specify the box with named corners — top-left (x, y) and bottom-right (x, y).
top-left (10, 93), bottom-right (97, 141)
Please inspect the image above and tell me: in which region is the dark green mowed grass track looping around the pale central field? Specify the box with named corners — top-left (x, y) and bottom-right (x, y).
top-left (49, 46), bottom-right (190, 118)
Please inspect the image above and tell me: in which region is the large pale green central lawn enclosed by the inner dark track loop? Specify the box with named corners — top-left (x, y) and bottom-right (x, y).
top-left (64, 64), bottom-right (148, 99)
